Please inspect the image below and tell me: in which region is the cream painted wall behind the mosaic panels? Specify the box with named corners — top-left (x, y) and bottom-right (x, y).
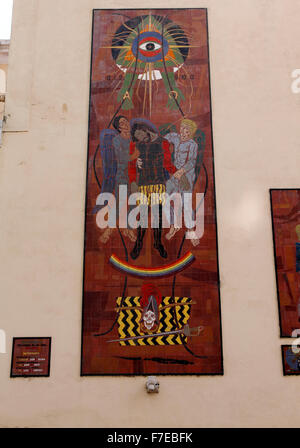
top-left (0, 0), bottom-right (300, 427)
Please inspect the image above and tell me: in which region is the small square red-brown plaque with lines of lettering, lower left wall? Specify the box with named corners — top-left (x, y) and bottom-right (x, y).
top-left (10, 338), bottom-right (51, 378)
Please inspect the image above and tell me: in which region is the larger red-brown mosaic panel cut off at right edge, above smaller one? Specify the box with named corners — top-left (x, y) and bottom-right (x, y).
top-left (270, 189), bottom-right (300, 337)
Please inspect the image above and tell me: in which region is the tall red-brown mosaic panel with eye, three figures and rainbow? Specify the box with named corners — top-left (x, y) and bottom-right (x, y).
top-left (81, 9), bottom-right (223, 375)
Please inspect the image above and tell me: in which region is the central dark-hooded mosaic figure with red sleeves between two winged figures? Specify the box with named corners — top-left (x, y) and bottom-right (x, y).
top-left (129, 119), bottom-right (176, 260)
